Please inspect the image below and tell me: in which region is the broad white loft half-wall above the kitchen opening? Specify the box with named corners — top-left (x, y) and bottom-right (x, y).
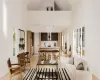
top-left (28, 11), bottom-right (71, 32)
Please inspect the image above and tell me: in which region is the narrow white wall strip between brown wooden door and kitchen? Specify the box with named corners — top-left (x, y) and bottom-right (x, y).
top-left (34, 33), bottom-right (39, 54)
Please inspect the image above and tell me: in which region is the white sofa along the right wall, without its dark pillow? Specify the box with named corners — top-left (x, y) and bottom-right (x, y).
top-left (60, 57), bottom-right (90, 80)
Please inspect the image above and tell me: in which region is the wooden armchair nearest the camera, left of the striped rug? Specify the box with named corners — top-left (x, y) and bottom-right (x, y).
top-left (7, 58), bottom-right (22, 80)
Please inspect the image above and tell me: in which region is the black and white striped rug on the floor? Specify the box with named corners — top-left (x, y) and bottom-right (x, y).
top-left (23, 68), bottom-right (71, 80)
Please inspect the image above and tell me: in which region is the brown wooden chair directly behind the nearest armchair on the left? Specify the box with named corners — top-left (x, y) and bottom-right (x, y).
top-left (17, 53), bottom-right (26, 71)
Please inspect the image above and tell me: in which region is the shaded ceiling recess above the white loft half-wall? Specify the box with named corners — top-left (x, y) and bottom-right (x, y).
top-left (27, 0), bottom-right (77, 11)
